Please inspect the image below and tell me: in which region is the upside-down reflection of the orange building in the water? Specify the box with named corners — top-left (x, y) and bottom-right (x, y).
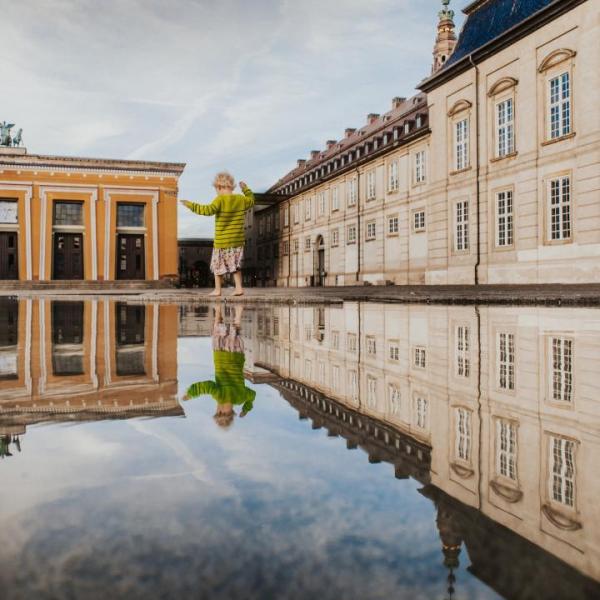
top-left (0, 298), bottom-right (183, 457)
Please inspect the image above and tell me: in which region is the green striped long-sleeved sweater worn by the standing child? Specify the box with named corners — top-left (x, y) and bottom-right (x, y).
top-left (186, 188), bottom-right (254, 248)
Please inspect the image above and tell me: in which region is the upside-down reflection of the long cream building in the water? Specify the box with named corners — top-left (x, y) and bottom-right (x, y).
top-left (245, 303), bottom-right (600, 598)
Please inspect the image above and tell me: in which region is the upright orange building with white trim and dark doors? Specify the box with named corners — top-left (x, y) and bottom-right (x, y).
top-left (0, 146), bottom-right (185, 285)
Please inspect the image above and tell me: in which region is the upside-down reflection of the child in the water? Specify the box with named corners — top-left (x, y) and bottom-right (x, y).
top-left (183, 304), bottom-right (256, 428)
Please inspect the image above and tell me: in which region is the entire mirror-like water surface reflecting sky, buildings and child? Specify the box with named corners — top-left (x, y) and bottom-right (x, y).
top-left (0, 300), bottom-right (600, 599)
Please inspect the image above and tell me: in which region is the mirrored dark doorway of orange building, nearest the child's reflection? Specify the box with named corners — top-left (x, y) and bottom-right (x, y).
top-left (115, 302), bottom-right (146, 376)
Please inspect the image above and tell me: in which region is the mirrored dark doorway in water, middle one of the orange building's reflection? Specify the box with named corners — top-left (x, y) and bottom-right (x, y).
top-left (52, 301), bottom-right (84, 376)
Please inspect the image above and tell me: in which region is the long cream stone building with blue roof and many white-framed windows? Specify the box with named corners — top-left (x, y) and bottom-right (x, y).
top-left (247, 0), bottom-right (600, 286)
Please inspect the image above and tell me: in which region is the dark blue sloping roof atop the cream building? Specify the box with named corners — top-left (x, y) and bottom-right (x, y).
top-left (444, 0), bottom-right (556, 69)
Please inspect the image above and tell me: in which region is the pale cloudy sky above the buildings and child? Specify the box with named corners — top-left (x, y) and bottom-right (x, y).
top-left (0, 0), bottom-right (467, 237)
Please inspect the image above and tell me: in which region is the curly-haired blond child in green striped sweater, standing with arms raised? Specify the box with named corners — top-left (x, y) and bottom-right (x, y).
top-left (181, 171), bottom-right (254, 296)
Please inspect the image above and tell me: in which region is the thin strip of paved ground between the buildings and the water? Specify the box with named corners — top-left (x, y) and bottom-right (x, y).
top-left (0, 284), bottom-right (600, 306)
